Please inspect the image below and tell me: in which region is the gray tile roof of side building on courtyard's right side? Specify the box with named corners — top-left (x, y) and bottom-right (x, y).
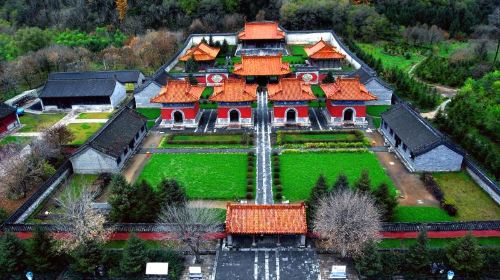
top-left (381, 103), bottom-right (458, 156)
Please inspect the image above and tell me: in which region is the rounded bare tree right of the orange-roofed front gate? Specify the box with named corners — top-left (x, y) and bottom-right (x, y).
top-left (313, 189), bottom-right (380, 257)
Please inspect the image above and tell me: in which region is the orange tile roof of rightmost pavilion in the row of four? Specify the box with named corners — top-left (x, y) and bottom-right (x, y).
top-left (321, 77), bottom-right (377, 101)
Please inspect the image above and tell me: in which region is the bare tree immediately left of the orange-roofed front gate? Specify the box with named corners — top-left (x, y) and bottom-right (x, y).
top-left (158, 204), bottom-right (222, 262)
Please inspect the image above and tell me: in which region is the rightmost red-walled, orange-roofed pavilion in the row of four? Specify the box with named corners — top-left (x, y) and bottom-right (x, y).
top-left (321, 77), bottom-right (377, 126)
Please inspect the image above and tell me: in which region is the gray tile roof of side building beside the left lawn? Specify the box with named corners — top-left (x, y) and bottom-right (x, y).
top-left (73, 106), bottom-right (147, 158)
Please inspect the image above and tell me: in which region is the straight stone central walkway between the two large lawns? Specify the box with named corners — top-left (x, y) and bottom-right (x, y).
top-left (255, 90), bottom-right (273, 204)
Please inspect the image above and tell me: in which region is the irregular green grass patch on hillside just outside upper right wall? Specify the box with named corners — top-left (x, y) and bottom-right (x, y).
top-left (357, 43), bottom-right (425, 71)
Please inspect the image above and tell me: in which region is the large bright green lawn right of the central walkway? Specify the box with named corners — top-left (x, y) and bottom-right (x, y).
top-left (280, 152), bottom-right (396, 201)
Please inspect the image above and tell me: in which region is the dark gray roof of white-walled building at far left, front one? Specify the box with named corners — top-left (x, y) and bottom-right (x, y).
top-left (39, 79), bottom-right (116, 98)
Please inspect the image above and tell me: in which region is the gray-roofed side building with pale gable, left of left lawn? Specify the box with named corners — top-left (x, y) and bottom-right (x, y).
top-left (70, 106), bottom-right (147, 174)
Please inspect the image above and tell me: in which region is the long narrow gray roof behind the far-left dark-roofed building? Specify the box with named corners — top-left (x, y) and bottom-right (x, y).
top-left (49, 70), bottom-right (141, 83)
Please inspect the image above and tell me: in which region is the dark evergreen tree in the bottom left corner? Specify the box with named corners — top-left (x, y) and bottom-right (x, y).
top-left (0, 233), bottom-right (27, 279)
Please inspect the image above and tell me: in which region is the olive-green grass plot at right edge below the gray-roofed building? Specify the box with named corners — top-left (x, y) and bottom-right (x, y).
top-left (432, 172), bottom-right (500, 221)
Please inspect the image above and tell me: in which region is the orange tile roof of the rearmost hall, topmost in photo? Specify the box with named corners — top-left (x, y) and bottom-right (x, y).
top-left (238, 21), bottom-right (285, 40)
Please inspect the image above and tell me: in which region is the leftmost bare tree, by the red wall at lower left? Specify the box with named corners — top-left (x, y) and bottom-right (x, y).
top-left (57, 186), bottom-right (112, 251)
